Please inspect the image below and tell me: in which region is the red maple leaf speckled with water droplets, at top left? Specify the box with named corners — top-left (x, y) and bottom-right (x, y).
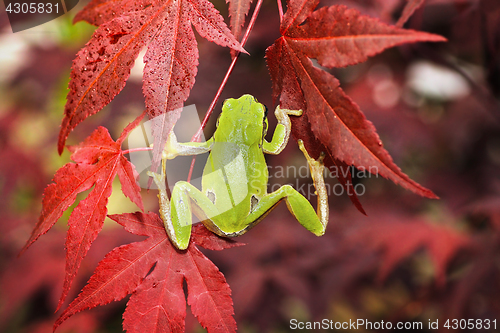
top-left (58, 0), bottom-right (245, 156)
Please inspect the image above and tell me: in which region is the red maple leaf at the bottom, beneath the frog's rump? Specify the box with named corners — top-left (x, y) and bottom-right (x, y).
top-left (54, 212), bottom-right (241, 333)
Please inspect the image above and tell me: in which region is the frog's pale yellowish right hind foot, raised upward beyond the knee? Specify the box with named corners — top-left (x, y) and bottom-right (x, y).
top-left (298, 140), bottom-right (329, 228)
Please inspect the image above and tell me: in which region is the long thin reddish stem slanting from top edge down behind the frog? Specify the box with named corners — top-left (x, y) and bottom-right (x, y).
top-left (187, 0), bottom-right (263, 182)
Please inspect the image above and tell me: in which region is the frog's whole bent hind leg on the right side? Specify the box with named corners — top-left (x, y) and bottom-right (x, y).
top-left (245, 140), bottom-right (329, 236)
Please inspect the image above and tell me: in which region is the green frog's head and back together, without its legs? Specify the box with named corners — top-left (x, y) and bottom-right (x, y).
top-left (202, 95), bottom-right (267, 229)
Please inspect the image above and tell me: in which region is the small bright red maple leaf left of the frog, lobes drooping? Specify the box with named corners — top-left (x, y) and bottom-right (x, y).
top-left (23, 115), bottom-right (144, 307)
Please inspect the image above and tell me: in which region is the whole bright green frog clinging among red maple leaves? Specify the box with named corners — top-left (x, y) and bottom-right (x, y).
top-left (150, 95), bottom-right (328, 250)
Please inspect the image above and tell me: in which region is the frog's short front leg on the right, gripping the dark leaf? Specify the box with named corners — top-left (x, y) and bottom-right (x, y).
top-left (263, 106), bottom-right (302, 155)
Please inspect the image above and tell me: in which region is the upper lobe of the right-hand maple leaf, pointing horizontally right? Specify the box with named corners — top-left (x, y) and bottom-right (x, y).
top-left (284, 6), bottom-right (446, 67)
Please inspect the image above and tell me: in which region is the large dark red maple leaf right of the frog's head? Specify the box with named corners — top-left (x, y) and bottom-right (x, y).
top-left (266, 0), bottom-right (445, 198)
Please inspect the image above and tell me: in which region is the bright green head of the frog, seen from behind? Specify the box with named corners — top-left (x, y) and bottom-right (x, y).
top-left (216, 95), bottom-right (268, 145)
